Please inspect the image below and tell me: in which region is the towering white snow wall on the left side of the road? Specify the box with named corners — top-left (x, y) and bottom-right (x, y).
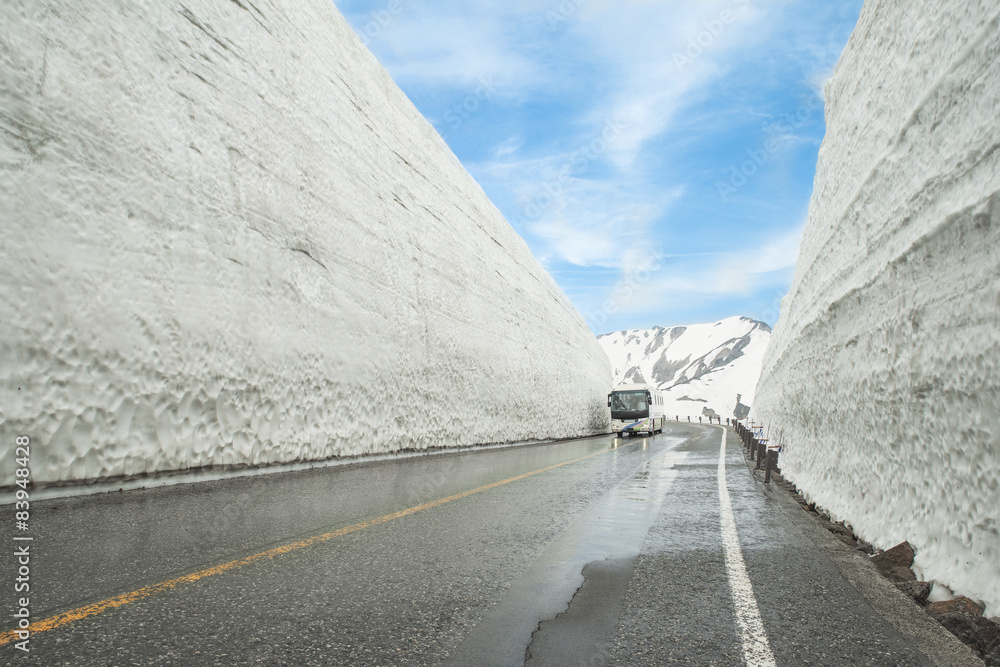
top-left (0, 0), bottom-right (610, 485)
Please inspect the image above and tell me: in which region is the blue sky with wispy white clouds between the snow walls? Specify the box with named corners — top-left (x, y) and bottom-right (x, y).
top-left (336, 0), bottom-right (862, 334)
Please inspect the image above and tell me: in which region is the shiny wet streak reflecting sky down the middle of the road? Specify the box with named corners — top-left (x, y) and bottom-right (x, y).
top-left (446, 436), bottom-right (688, 666)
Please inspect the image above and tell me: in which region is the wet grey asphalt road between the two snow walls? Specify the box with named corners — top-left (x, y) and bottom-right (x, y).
top-left (0, 424), bottom-right (972, 665)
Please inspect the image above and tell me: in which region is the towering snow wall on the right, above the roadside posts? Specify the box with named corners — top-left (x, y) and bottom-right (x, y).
top-left (751, 0), bottom-right (1000, 616)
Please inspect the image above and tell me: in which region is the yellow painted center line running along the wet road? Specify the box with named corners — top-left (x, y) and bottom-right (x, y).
top-left (0, 441), bottom-right (638, 646)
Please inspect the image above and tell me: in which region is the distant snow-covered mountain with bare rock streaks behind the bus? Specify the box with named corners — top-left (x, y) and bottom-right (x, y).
top-left (597, 317), bottom-right (771, 421)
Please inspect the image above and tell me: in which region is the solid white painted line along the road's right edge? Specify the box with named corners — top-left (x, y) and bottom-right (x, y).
top-left (719, 428), bottom-right (775, 667)
